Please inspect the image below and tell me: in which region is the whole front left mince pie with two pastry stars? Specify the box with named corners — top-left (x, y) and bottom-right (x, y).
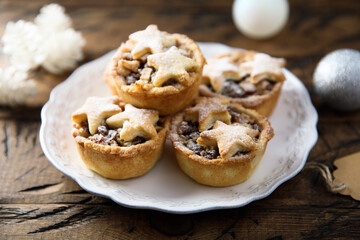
top-left (72, 96), bottom-right (170, 179)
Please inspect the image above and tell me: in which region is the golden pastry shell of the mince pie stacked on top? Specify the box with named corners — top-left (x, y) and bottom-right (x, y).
top-left (104, 34), bottom-right (205, 115)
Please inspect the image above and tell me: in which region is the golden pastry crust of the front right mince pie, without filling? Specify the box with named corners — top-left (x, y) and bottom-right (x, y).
top-left (168, 98), bottom-right (274, 187)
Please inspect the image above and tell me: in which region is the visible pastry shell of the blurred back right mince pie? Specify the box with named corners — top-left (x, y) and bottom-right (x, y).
top-left (199, 82), bottom-right (284, 117)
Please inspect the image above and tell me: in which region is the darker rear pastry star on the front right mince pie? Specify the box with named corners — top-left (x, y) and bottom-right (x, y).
top-left (185, 97), bottom-right (231, 132)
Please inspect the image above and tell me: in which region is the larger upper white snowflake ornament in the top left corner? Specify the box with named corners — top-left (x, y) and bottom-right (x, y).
top-left (2, 4), bottom-right (85, 74)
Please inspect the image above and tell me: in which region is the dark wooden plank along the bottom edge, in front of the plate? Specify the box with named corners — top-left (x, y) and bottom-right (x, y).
top-left (0, 204), bottom-right (360, 239)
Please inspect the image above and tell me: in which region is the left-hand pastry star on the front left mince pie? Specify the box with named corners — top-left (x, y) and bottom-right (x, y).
top-left (72, 96), bottom-right (122, 135)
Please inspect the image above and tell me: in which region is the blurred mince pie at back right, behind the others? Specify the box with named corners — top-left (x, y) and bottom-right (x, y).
top-left (200, 50), bottom-right (285, 116)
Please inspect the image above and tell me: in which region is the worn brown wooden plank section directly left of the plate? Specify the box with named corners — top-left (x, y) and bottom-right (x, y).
top-left (0, 120), bottom-right (62, 196)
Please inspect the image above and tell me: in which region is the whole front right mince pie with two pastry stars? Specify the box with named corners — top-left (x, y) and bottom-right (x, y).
top-left (168, 97), bottom-right (273, 187)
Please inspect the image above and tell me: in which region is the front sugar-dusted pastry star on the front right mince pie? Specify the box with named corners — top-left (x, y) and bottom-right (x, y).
top-left (197, 121), bottom-right (259, 160)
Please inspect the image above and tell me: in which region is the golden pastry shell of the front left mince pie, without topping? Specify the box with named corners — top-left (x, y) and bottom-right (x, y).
top-left (72, 117), bottom-right (170, 179)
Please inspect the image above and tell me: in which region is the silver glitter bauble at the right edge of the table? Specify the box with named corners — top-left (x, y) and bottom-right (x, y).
top-left (313, 49), bottom-right (360, 111)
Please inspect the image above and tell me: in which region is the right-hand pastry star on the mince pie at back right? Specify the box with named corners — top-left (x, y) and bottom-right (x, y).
top-left (240, 53), bottom-right (285, 84)
